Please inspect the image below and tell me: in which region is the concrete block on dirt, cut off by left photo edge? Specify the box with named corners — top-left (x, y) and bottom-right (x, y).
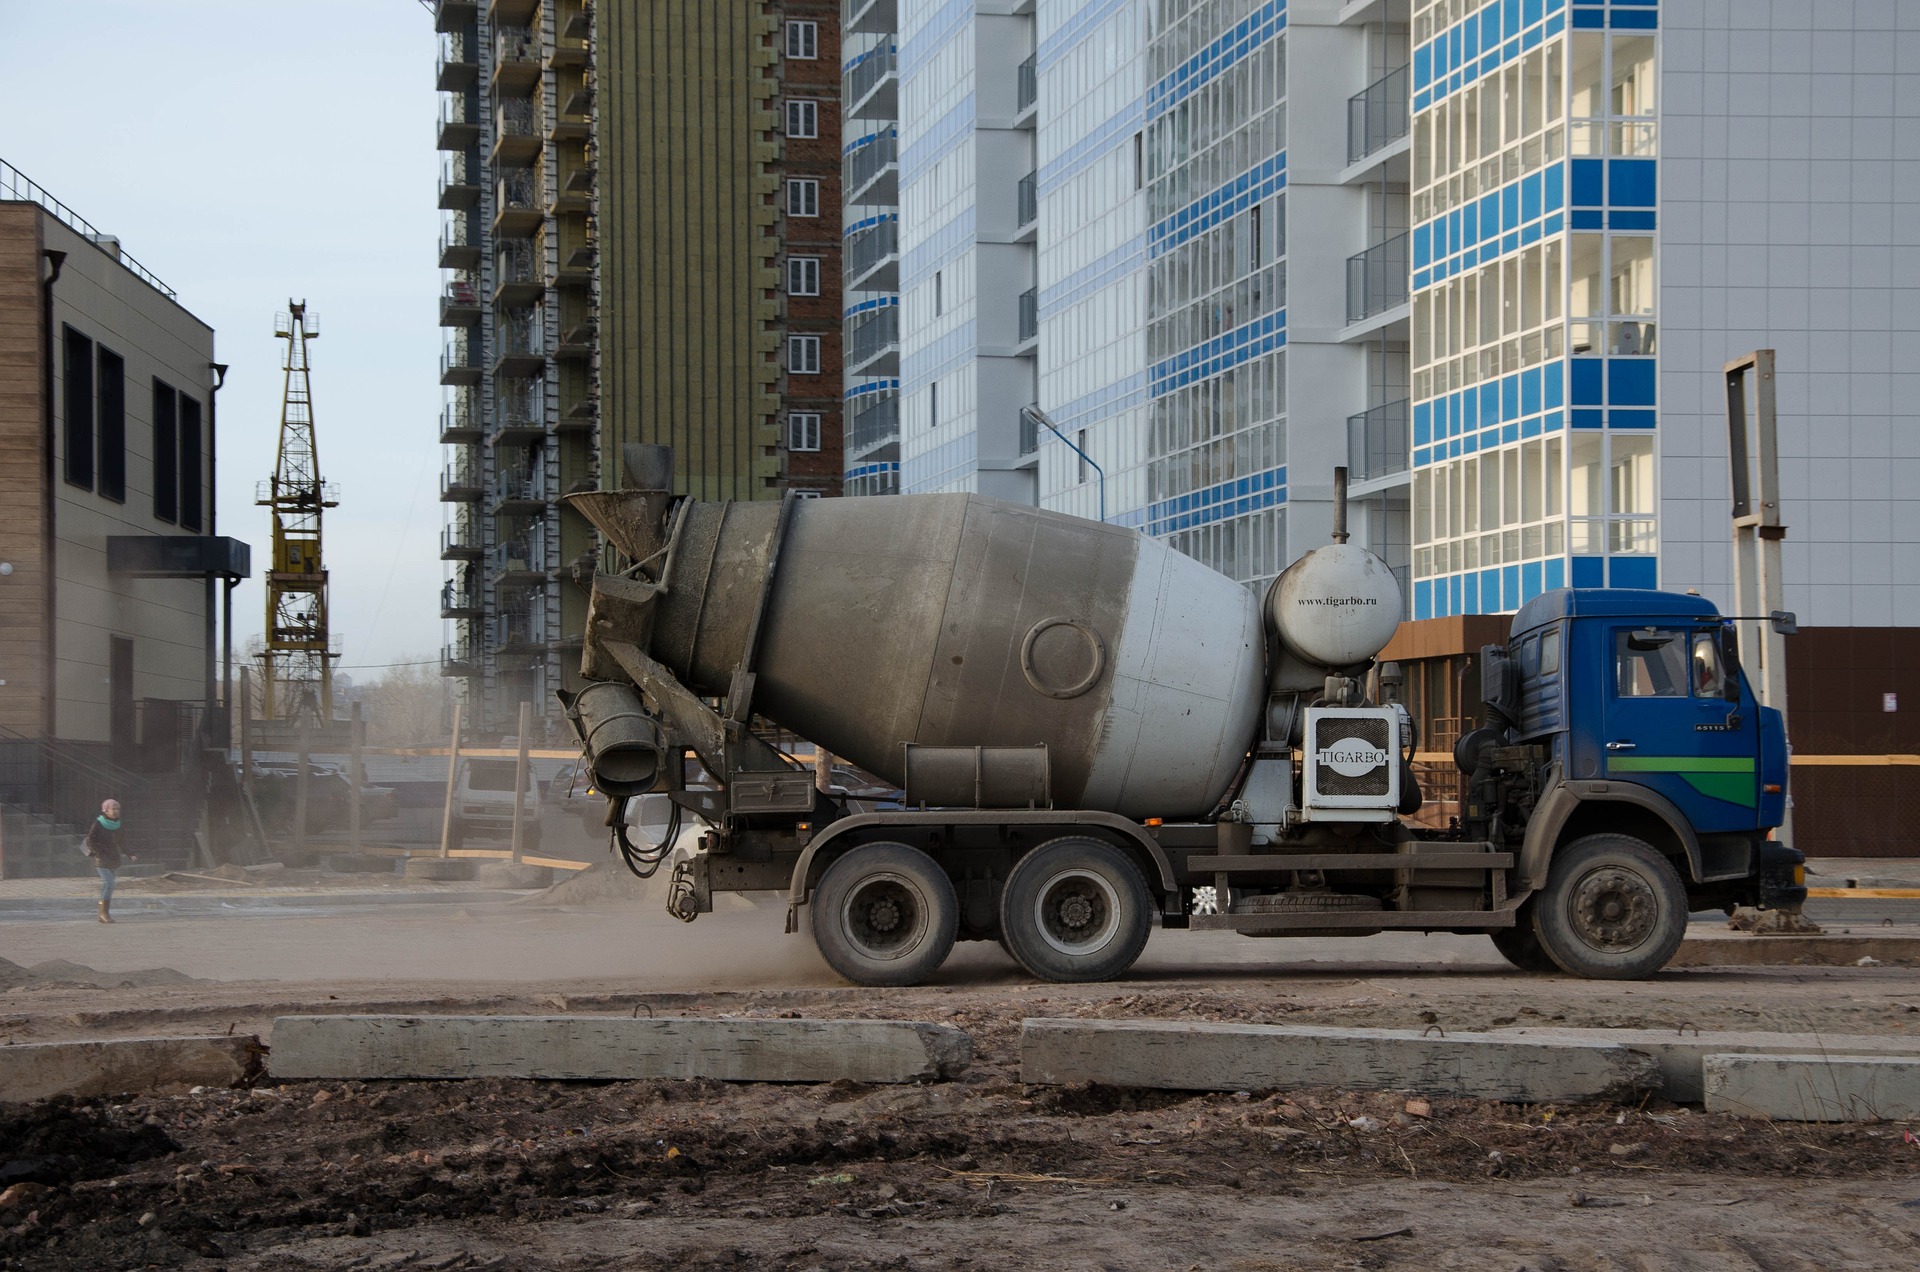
top-left (0, 1034), bottom-right (263, 1103)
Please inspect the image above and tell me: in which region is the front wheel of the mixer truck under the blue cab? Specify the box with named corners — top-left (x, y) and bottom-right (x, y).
top-left (1528, 834), bottom-right (1688, 980)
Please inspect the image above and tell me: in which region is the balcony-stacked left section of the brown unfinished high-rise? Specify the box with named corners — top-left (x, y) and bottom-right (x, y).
top-left (434, 0), bottom-right (599, 730)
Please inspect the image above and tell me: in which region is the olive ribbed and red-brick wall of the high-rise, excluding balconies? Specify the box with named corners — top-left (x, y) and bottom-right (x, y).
top-left (593, 0), bottom-right (841, 500)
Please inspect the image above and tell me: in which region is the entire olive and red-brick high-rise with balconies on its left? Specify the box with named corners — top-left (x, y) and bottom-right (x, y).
top-left (434, 0), bottom-right (841, 732)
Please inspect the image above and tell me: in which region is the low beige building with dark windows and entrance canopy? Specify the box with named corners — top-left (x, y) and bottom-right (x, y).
top-left (0, 163), bottom-right (248, 874)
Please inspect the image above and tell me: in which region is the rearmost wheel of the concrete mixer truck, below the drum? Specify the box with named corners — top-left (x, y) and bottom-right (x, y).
top-left (808, 844), bottom-right (960, 986)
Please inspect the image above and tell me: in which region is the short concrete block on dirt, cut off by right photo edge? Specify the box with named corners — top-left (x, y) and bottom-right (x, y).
top-left (1701, 1055), bottom-right (1920, 1122)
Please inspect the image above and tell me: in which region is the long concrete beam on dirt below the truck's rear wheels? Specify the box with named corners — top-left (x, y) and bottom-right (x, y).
top-left (273, 1016), bottom-right (973, 1082)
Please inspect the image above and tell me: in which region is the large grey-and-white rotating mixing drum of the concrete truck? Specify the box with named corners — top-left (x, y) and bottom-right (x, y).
top-left (595, 494), bottom-right (1265, 817)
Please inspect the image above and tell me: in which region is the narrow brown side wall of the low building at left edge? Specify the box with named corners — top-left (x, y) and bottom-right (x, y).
top-left (0, 204), bottom-right (48, 736)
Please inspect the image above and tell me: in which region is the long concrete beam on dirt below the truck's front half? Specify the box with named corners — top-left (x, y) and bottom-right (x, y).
top-left (1020, 1020), bottom-right (1661, 1103)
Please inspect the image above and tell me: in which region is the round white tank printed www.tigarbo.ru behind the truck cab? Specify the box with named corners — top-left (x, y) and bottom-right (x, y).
top-left (1267, 544), bottom-right (1402, 669)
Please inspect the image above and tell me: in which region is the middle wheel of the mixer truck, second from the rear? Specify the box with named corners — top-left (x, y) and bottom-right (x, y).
top-left (1000, 838), bottom-right (1154, 984)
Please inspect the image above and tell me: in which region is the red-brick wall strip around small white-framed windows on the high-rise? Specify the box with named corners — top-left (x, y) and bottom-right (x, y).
top-left (770, 0), bottom-right (845, 496)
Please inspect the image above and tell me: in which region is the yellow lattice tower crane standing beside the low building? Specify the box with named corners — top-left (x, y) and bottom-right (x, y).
top-left (257, 300), bottom-right (340, 726)
